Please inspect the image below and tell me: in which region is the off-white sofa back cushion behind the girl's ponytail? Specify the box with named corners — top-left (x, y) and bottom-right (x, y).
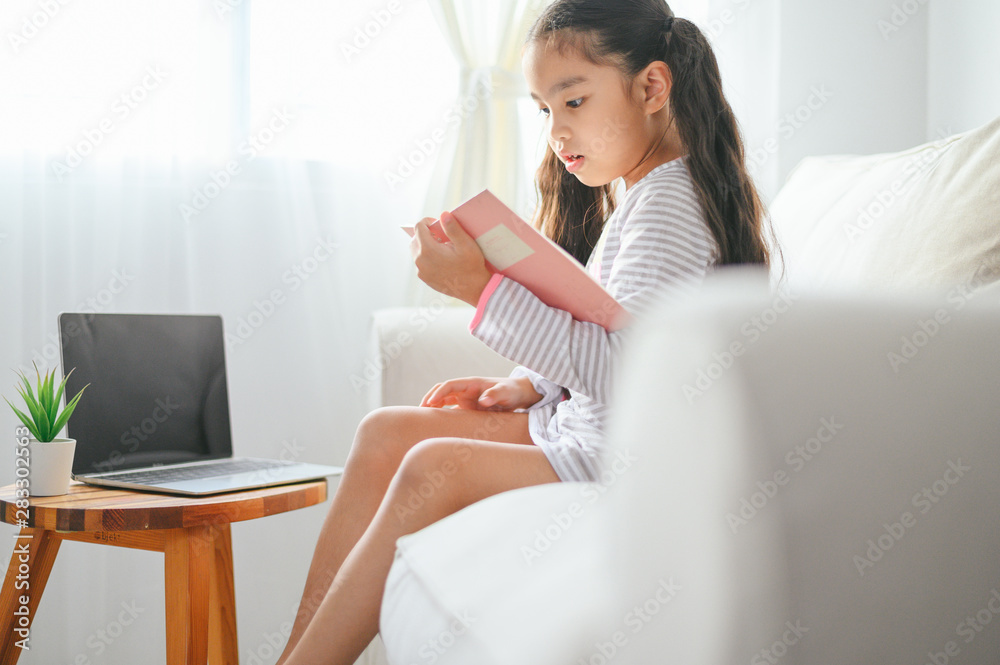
top-left (771, 118), bottom-right (1000, 289)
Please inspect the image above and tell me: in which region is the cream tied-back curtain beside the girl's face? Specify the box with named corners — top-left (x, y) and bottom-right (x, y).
top-left (402, 0), bottom-right (551, 304)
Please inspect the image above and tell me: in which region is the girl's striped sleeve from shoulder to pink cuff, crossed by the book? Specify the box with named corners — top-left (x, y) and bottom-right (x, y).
top-left (470, 176), bottom-right (713, 404)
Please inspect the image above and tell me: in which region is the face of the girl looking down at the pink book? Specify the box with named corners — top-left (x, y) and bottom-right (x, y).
top-left (522, 43), bottom-right (662, 187)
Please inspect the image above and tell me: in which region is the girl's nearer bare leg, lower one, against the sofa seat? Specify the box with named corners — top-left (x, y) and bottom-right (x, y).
top-left (287, 438), bottom-right (559, 665)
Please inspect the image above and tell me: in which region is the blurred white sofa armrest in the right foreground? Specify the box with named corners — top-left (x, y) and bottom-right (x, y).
top-left (600, 272), bottom-right (1000, 665)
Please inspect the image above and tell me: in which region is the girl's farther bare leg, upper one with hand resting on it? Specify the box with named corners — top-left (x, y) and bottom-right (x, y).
top-left (278, 406), bottom-right (540, 665)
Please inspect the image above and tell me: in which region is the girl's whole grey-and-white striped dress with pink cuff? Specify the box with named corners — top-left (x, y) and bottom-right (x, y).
top-left (469, 158), bottom-right (719, 481)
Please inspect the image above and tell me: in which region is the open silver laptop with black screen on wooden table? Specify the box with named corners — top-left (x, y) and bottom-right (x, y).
top-left (59, 312), bottom-right (343, 496)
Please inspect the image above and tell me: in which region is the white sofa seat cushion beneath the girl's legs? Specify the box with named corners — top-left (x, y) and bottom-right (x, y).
top-left (380, 483), bottom-right (613, 665)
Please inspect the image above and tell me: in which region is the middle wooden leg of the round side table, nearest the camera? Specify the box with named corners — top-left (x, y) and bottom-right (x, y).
top-left (163, 526), bottom-right (212, 665)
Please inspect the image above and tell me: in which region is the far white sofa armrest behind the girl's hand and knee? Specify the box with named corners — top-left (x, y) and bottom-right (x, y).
top-left (363, 306), bottom-right (516, 409)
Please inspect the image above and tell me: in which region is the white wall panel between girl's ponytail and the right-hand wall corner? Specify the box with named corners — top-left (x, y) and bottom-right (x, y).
top-left (779, 0), bottom-right (927, 184)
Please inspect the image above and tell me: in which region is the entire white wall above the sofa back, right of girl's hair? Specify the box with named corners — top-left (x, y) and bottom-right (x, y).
top-left (716, 0), bottom-right (1000, 201)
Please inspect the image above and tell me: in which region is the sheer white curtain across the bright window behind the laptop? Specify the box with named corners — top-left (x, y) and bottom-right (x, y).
top-left (0, 0), bottom-right (453, 665)
